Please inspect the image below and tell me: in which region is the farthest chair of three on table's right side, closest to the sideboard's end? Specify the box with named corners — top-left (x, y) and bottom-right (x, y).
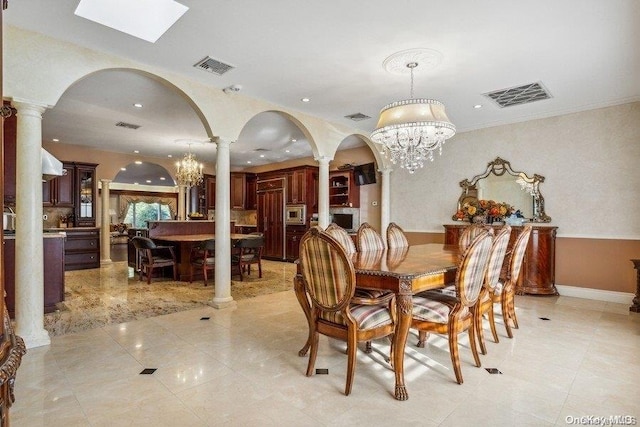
top-left (493, 225), bottom-right (532, 338)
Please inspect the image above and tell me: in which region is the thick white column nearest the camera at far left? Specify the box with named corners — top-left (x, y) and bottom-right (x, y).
top-left (13, 100), bottom-right (51, 348)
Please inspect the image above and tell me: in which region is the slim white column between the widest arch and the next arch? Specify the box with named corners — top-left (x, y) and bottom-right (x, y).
top-left (211, 139), bottom-right (236, 308)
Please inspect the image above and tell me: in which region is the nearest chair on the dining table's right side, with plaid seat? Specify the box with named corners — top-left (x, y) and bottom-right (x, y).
top-left (411, 231), bottom-right (491, 384)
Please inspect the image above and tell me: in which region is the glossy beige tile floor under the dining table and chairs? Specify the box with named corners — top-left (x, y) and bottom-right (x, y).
top-left (11, 266), bottom-right (640, 427)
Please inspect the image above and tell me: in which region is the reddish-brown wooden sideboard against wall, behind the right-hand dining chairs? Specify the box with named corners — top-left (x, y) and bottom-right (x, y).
top-left (444, 223), bottom-right (558, 295)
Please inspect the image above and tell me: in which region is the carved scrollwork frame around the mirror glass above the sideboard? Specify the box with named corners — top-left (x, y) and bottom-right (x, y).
top-left (452, 157), bottom-right (551, 222)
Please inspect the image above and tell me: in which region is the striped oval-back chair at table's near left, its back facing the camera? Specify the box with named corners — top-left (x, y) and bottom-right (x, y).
top-left (296, 228), bottom-right (395, 395)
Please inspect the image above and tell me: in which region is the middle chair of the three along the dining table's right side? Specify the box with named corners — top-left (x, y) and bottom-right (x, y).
top-left (473, 225), bottom-right (511, 354)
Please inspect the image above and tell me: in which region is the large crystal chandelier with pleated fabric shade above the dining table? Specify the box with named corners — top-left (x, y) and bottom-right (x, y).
top-left (371, 51), bottom-right (456, 173)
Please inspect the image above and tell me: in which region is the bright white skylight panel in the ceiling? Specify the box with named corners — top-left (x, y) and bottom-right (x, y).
top-left (75, 0), bottom-right (189, 43)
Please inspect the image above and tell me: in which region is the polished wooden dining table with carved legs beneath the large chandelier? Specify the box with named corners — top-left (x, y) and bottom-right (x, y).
top-left (294, 243), bottom-right (460, 400)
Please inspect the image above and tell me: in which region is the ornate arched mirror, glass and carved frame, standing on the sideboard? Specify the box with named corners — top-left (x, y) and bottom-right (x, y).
top-left (453, 157), bottom-right (551, 222)
